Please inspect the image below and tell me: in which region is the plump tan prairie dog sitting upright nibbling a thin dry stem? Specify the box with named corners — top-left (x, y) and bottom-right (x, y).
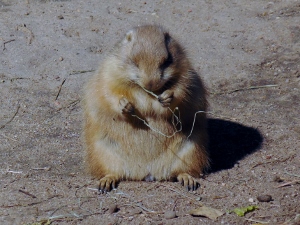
top-left (84, 25), bottom-right (209, 192)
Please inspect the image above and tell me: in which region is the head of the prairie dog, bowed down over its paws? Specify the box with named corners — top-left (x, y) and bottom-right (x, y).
top-left (118, 25), bottom-right (186, 92)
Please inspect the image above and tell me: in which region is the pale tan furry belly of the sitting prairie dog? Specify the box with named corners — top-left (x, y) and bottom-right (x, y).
top-left (99, 116), bottom-right (185, 180)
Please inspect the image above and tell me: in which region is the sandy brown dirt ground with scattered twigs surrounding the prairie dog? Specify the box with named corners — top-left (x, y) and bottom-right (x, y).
top-left (0, 0), bottom-right (300, 225)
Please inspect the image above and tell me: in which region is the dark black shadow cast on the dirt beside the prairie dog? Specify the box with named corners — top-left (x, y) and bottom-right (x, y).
top-left (208, 119), bottom-right (263, 173)
